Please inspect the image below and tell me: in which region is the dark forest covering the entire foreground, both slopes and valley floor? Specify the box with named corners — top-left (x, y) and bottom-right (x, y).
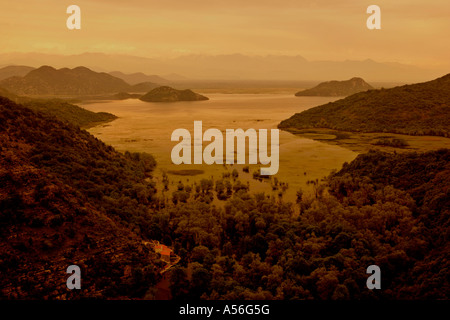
top-left (0, 98), bottom-right (450, 300)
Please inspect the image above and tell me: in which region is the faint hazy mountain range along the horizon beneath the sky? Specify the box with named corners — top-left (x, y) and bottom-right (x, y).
top-left (0, 53), bottom-right (442, 83)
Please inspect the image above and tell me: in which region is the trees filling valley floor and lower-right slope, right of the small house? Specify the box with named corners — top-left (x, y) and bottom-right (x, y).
top-left (152, 150), bottom-right (450, 299)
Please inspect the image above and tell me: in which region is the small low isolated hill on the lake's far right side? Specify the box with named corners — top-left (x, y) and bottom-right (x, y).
top-left (295, 78), bottom-right (373, 97)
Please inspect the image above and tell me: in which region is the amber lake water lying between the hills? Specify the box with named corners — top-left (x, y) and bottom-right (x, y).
top-left (82, 92), bottom-right (357, 201)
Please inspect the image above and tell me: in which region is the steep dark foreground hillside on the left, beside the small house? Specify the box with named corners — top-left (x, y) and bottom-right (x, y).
top-left (0, 97), bottom-right (161, 299)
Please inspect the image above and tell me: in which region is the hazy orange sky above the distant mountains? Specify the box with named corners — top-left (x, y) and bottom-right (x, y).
top-left (0, 0), bottom-right (450, 67)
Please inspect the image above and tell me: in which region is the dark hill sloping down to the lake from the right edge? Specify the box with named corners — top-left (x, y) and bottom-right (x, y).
top-left (278, 74), bottom-right (450, 137)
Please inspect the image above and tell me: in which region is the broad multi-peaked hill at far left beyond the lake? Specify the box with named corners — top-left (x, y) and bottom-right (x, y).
top-left (0, 66), bottom-right (130, 95)
